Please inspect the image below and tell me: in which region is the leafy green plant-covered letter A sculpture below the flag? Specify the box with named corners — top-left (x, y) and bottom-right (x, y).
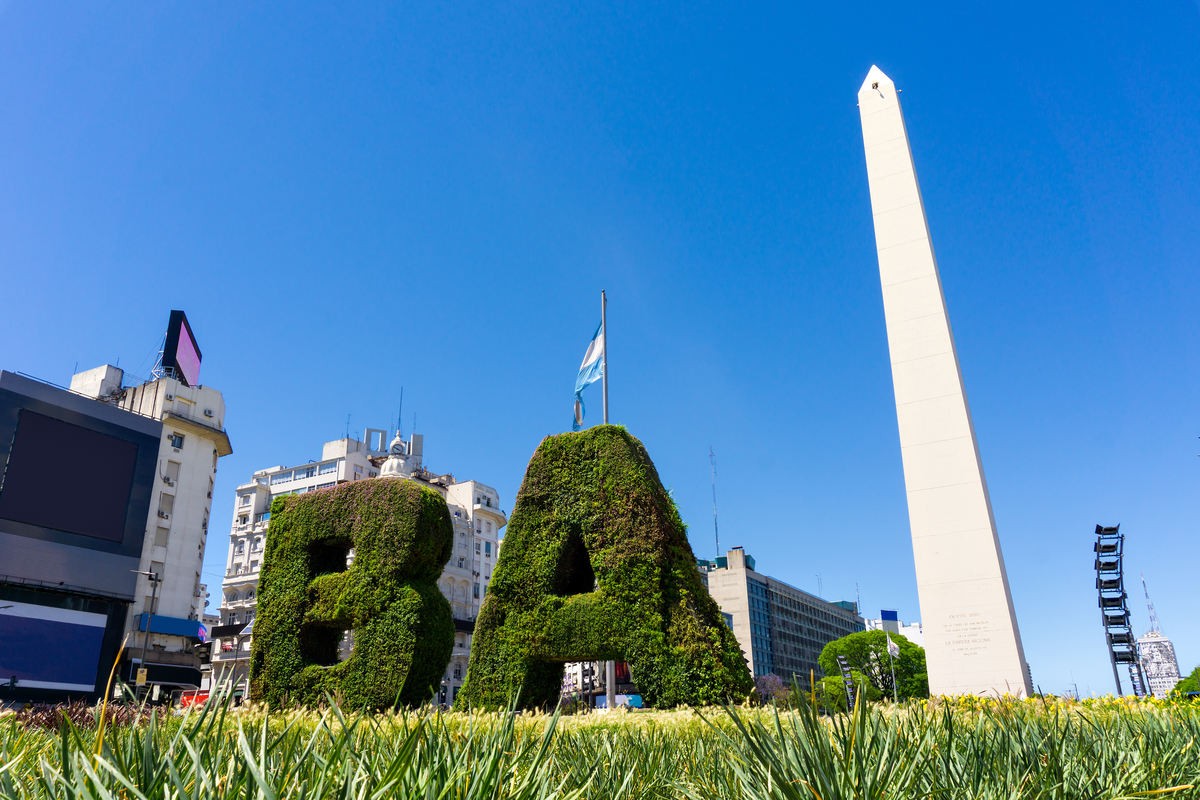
top-left (457, 426), bottom-right (754, 708)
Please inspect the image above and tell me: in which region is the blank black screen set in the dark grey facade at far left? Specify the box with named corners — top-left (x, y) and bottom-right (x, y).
top-left (0, 409), bottom-right (138, 542)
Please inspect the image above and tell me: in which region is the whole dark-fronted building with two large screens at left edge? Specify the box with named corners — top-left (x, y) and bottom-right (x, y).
top-left (0, 372), bottom-right (163, 702)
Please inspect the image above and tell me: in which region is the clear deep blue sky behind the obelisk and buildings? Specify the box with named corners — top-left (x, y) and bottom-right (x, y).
top-left (0, 2), bottom-right (1200, 693)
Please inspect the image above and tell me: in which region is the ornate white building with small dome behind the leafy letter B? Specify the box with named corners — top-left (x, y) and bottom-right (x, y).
top-left (212, 428), bottom-right (508, 703)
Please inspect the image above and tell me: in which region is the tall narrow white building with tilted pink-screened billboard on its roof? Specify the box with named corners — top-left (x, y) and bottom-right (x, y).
top-left (71, 365), bottom-right (233, 688)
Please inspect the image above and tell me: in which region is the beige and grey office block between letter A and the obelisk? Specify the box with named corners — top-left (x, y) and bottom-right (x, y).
top-left (697, 547), bottom-right (864, 685)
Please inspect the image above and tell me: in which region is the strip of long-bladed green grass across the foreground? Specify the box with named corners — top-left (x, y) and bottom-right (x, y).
top-left (0, 686), bottom-right (1200, 800)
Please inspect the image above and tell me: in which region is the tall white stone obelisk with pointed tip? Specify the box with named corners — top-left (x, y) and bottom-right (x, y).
top-left (858, 66), bottom-right (1031, 697)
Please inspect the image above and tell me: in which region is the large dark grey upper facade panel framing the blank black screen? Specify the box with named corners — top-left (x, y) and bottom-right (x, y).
top-left (0, 372), bottom-right (162, 606)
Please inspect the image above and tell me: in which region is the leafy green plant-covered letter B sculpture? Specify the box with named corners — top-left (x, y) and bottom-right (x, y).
top-left (250, 479), bottom-right (454, 709)
